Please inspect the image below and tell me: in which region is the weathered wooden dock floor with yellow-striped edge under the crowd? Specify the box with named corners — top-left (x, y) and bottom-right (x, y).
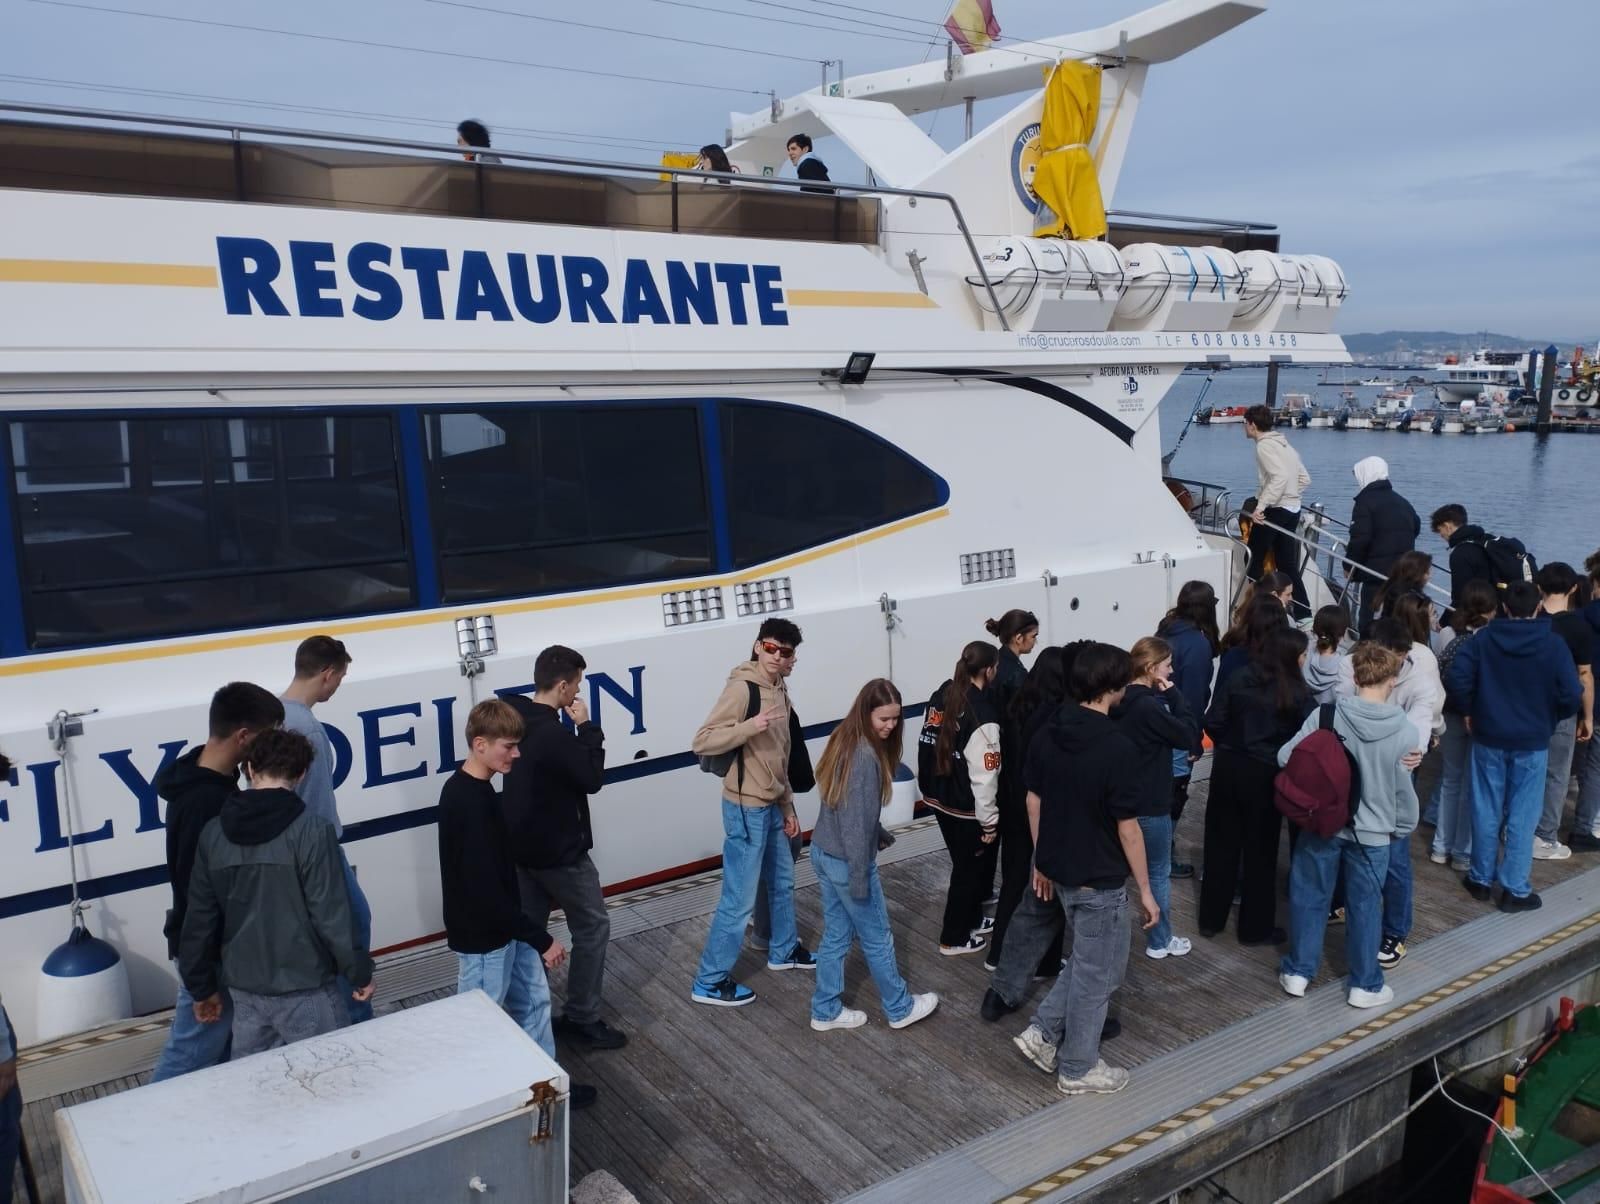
top-left (19, 765), bottom-right (1600, 1204)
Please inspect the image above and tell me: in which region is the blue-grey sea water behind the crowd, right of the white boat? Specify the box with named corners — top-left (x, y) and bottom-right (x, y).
top-left (1162, 367), bottom-right (1600, 575)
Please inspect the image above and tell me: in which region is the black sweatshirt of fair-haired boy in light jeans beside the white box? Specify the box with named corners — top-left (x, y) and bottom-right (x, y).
top-left (438, 769), bottom-right (550, 953)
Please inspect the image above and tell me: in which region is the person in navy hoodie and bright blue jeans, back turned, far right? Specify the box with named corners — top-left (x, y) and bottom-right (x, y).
top-left (1445, 581), bottom-right (1584, 911)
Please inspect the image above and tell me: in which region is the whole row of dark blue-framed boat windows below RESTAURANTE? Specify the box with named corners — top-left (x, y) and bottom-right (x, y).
top-left (0, 402), bottom-right (946, 648)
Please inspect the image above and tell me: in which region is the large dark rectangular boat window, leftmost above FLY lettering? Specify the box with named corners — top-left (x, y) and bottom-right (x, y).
top-left (8, 415), bottom-right (411, 648)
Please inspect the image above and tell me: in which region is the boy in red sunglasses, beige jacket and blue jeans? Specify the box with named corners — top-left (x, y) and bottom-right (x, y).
top-left (690, 618), bottom-right (816, 1007)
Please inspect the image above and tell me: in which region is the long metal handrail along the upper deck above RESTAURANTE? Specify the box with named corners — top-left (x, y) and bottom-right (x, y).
top-left (0, 101), bottom-right (1011, 331)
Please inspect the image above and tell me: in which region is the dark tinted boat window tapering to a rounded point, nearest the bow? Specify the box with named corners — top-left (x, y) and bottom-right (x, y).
top-left (722, 402), bottom-right (947, 568)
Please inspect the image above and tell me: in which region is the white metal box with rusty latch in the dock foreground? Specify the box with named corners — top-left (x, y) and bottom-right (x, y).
top-left (56, 991), bottom-right (568, 1204)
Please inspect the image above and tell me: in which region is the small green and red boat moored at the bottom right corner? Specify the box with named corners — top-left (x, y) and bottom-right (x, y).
top-left (1472, 999), bottom-right (1600, 1204)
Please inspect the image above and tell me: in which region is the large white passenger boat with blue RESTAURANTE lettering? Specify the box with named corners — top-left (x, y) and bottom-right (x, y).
top-left (0, 0), bottom-right (1347, 1044)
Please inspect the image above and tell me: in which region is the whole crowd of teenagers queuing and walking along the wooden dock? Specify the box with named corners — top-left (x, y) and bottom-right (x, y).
top-left (0, 473), bottom-right (1600, 1183)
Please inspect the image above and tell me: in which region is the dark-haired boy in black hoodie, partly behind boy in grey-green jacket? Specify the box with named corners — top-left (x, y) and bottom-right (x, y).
top-left (152, 682), bottom-right (283, 1082)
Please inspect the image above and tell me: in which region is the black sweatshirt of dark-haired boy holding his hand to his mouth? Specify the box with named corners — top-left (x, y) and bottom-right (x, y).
top-left (499, 695), bottom-right (605, 869)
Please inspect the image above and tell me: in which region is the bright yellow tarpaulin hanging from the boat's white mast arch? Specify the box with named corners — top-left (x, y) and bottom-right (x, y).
top-left (1034, 62), bottom-right (1106, 239)
